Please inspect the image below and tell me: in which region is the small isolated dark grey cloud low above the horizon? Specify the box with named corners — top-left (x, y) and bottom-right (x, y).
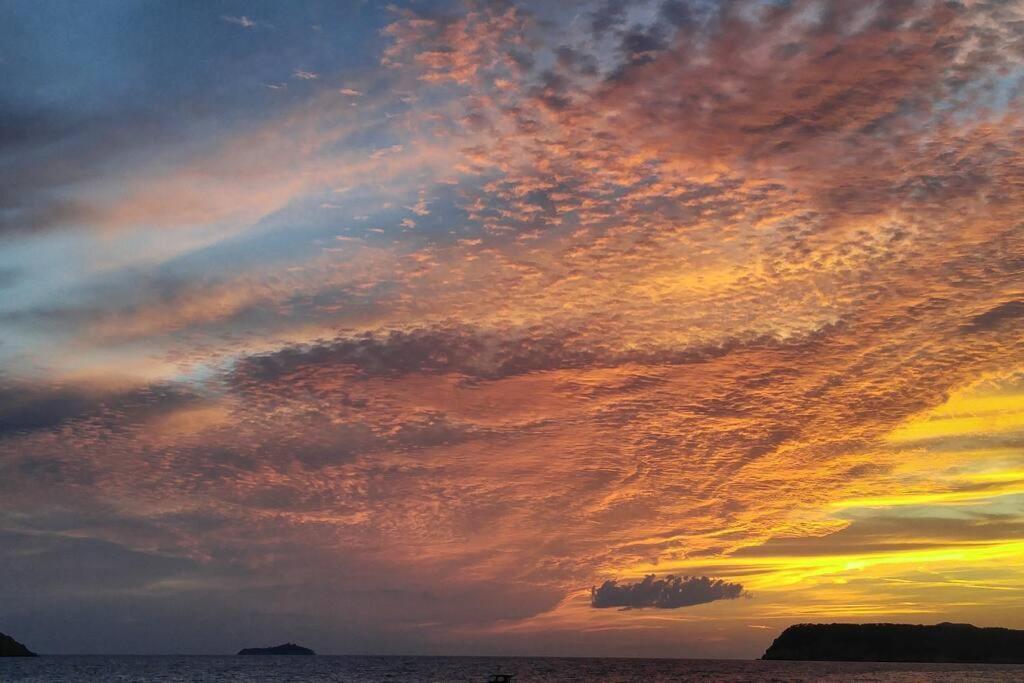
top-left (590, 574), bottom-right (744, 609)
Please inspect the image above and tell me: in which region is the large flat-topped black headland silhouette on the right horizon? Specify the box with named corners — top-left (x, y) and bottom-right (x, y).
top-left (761, 623), bottom-right (1024, 664)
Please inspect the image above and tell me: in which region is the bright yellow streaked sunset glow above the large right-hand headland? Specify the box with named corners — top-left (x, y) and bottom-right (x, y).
top-left (589, 370), bottom-right (1024, 634)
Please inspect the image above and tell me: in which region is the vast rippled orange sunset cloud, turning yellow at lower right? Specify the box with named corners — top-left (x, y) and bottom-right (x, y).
top-left (6, 2), bottom-right (1024, 655)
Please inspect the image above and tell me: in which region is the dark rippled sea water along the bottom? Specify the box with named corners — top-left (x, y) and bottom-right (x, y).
top-left (0, 655), bottom-right (1024, 683)
